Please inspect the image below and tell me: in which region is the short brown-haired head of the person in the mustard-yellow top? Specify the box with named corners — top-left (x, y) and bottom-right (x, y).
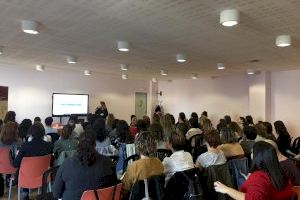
top-left (134, 131), bottom-right (157, 157)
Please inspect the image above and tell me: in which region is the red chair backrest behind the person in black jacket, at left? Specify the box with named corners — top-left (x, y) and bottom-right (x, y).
top-left (18, 154), bottom-right (51, 189)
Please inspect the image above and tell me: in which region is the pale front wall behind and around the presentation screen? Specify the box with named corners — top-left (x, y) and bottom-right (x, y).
top-left (0, 65), bottom-right (149, 121)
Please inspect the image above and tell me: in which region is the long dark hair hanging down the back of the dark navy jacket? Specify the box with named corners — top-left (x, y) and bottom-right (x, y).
top-left (77, 130), bottom-right (97, 166)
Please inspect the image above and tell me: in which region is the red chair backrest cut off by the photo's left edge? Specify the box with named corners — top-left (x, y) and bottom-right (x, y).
top-left (0, 147), bottom-right (17, 174)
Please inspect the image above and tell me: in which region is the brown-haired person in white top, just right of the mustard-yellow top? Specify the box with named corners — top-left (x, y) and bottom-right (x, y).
top-left (163, 132), bottom-right (194, 183)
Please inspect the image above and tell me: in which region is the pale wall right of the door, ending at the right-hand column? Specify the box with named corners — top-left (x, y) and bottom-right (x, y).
top-left (158, 76), bottom-right (248, 125)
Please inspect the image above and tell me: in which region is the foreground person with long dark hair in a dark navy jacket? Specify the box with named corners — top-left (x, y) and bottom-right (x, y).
top-left (53, 130), bottom-right (116, 200)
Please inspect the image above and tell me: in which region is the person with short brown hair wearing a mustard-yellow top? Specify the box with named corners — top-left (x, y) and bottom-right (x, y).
top-left (122, 132), bottom-right (164, 196)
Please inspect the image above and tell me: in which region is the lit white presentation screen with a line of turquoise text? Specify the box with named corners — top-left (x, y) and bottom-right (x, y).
top-left (52, 93), bottom-right (89, 116)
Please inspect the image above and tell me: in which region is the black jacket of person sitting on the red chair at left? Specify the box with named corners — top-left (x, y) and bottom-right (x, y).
top-left (13, 139), bottom-right (52, 168)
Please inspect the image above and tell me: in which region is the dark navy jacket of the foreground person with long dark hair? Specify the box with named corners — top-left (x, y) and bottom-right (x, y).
top-left (53, 154), bottom-right (117, 200)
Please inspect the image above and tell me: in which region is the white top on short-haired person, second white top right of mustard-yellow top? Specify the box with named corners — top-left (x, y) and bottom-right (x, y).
top-left (196, 150), bottom-right (226, 168)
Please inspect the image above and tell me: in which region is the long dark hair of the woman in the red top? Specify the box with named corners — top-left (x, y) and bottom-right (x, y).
top-left (251, 141), bottom-right (288, 190)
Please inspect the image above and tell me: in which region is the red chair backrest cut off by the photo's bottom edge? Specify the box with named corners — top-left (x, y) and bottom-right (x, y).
top-left (81, 183), bottom-right (122, 200)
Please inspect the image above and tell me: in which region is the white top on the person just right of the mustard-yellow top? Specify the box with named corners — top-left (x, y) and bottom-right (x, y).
top-left (163, 150), bottom-right (194, 183)
